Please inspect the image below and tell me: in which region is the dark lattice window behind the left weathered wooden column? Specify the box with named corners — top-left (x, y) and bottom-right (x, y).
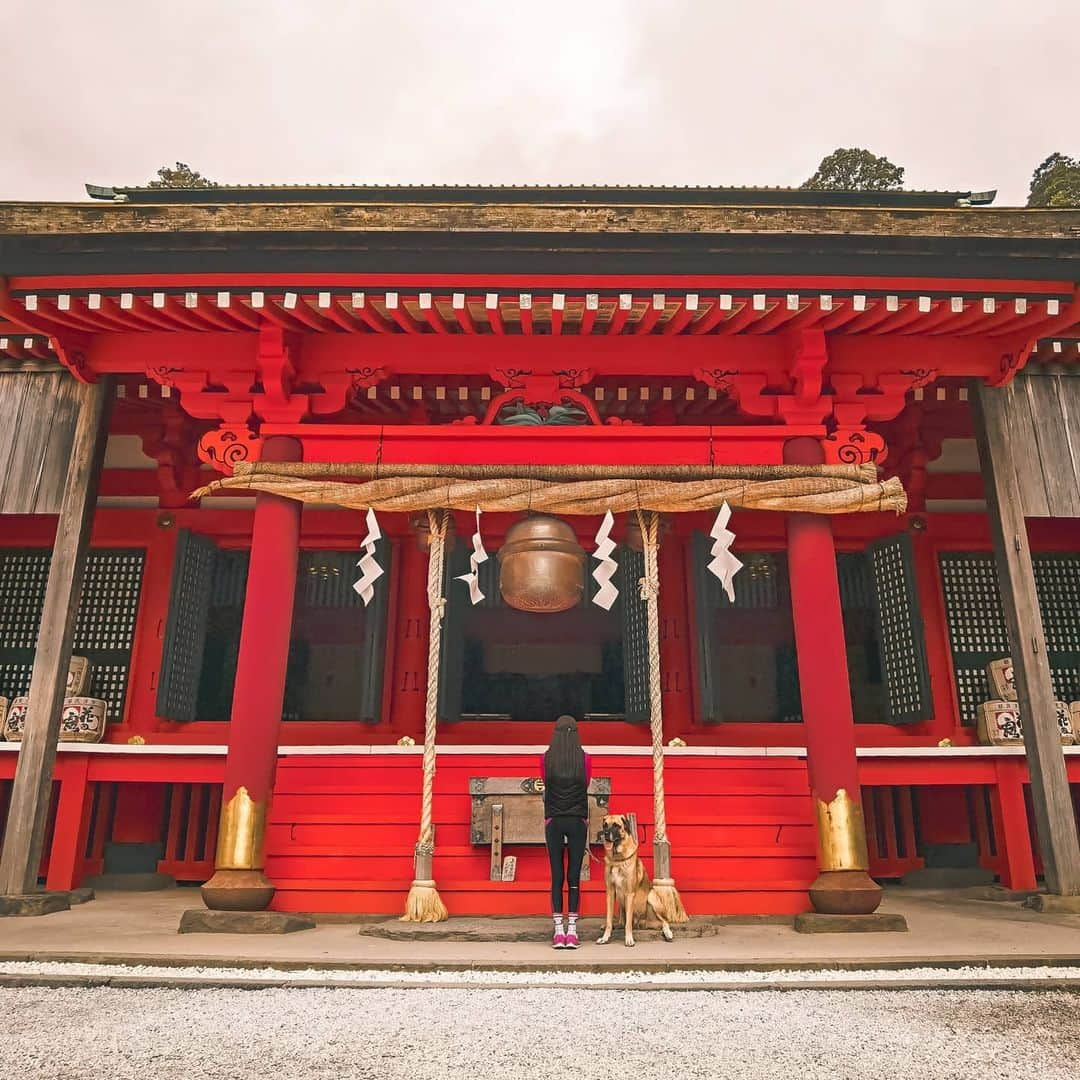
top-left (0, 548), bottom-right (145, 724)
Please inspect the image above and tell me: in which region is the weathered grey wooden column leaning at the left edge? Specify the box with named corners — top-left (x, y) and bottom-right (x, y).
top-left (0, 379), bottom-right (111, 895)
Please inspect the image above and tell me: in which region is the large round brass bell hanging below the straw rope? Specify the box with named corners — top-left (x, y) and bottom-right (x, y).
top-left (498, 514), bottom-right (585, 612)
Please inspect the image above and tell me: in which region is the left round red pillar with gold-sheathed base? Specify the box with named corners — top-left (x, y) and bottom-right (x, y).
top-left (202, 437), bottom-right (300, 910)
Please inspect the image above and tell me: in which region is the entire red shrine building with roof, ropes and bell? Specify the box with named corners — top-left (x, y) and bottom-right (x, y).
top-left (0, 187), bottom-right (1080, 918)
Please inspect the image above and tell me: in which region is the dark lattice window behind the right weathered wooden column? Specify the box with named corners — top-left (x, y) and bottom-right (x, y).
top-left (939, 552), bottom-right (1080, 725)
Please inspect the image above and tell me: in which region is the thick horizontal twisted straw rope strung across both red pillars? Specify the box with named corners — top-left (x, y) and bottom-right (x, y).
top-left (192, 464), bottom-right (907, 514)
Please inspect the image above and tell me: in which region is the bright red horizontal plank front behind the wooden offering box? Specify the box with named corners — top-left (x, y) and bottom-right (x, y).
top-left (267, 754), bottom-right (816, 915)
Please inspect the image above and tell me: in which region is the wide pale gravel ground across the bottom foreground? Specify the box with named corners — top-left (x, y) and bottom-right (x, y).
top-left (0, 988), bottom-right (1080, 1080)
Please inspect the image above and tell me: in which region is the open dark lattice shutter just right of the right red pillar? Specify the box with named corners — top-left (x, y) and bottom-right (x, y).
top-left (870, 532), bottom-right (930, 724)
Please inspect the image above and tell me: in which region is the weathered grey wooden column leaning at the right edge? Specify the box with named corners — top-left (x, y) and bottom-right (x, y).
top-left (972, 382), bottom-right (1080, 896)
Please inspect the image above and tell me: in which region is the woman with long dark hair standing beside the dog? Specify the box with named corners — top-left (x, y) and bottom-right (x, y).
top-left (540, 716), bottom-right (592, 948)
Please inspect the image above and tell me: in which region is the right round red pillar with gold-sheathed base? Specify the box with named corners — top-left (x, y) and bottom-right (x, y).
top-left (784, 438), bottom-right (881, 915)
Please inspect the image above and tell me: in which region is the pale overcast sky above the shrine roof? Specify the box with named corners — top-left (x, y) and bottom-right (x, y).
top-left (0, 0), bottom-right (1080, 204)
